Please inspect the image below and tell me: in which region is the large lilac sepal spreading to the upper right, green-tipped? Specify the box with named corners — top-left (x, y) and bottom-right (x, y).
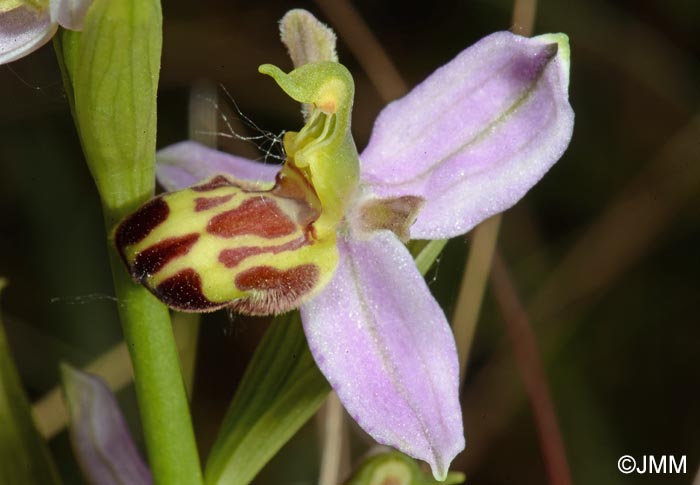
top-left (361, 32), bottom-right (574, 239)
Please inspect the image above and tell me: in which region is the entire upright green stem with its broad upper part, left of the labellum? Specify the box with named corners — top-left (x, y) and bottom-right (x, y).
top-left (56, 0), bottom-right (202, 485)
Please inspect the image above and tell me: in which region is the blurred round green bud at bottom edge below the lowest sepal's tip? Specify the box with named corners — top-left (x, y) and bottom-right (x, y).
top-left (345, 451), bottom-right (464, 485)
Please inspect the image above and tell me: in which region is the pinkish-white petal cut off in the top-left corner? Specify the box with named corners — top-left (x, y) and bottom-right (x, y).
top-left (0, 7), bottom-right (58, 64)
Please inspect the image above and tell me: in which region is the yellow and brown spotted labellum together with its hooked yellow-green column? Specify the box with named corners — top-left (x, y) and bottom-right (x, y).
top-left (114, 61), bottom-right (359, 315)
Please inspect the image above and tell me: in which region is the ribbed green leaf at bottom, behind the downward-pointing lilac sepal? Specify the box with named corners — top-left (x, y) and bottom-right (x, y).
top-left (205, 312), bottom-right (331, 485)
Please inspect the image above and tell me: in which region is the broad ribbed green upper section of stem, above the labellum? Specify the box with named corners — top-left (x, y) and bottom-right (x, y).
top-left (57, 0), bottom-right (162, 223)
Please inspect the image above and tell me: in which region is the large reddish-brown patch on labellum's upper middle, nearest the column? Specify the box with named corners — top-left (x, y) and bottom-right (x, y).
top-left (207, 196), bottom-right (297, 239)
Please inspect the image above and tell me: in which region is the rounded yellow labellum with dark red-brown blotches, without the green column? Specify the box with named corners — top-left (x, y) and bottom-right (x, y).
top-left (114, 165), bottom-right (338, 315)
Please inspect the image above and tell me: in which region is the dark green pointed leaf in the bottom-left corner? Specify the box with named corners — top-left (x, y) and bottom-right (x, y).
top-left (0, 278), bottom-right (61, 485)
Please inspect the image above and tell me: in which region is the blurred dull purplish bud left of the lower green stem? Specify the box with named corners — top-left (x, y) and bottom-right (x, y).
top-left (61, 364), bottom-right (153, 485)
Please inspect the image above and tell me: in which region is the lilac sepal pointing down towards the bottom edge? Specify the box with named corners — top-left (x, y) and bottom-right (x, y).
top-left (301, 231), bottom-right (464, 478)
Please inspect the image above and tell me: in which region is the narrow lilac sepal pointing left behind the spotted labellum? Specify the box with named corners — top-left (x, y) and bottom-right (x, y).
top-left (156, 141), bottom-right (281, 191)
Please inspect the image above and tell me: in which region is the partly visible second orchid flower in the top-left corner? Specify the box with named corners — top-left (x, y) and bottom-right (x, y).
top-left (0, 0), bottom-right (92, 64)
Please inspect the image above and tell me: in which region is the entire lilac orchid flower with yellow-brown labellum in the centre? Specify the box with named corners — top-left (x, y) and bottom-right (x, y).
top-left (114, 19), bottom-right (573, 479)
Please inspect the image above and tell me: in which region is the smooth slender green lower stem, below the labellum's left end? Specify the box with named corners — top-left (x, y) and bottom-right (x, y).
top-left (110, 251), bottom-right (202, 485)
